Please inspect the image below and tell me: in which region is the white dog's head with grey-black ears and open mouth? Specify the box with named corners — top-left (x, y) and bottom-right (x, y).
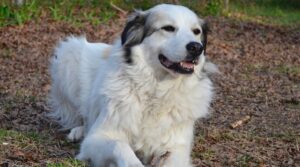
top-left (121, 4), bottom-right (207, 74)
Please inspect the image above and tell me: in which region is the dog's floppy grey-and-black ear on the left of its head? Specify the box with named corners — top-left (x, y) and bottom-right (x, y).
top-left (121, 11), bottom-right (147, 47)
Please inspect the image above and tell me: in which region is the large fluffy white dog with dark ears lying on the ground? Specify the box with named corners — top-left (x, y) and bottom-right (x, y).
top-left (50, 4), bottom-right (217, 167)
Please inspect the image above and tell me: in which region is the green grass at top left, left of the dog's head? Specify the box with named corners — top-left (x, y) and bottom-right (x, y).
top-left (0, 0), bottom-right (116, 26)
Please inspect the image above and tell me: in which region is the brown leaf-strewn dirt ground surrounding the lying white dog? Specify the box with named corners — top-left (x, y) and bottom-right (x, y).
top-left (0, 14), bottom-right (300, 167)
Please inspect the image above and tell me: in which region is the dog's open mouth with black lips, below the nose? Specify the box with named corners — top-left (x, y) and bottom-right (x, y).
top-left (158, 54), bottom-right (199, 74)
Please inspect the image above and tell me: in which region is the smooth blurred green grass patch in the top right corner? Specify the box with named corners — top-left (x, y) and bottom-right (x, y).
top-left (227, 0), bottom-right (300, 26)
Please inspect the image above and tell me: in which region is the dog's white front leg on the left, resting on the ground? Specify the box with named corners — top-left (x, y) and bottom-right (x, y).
top-left (77, 134), bottom-right (144, 167)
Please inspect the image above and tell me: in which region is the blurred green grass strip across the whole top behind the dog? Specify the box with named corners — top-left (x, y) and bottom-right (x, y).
top-left (0, 0), bottom-right (300, 26)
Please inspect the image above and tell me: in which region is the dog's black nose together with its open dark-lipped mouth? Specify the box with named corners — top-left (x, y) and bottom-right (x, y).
top-left (158, 42), bottom-right (203, 74)
